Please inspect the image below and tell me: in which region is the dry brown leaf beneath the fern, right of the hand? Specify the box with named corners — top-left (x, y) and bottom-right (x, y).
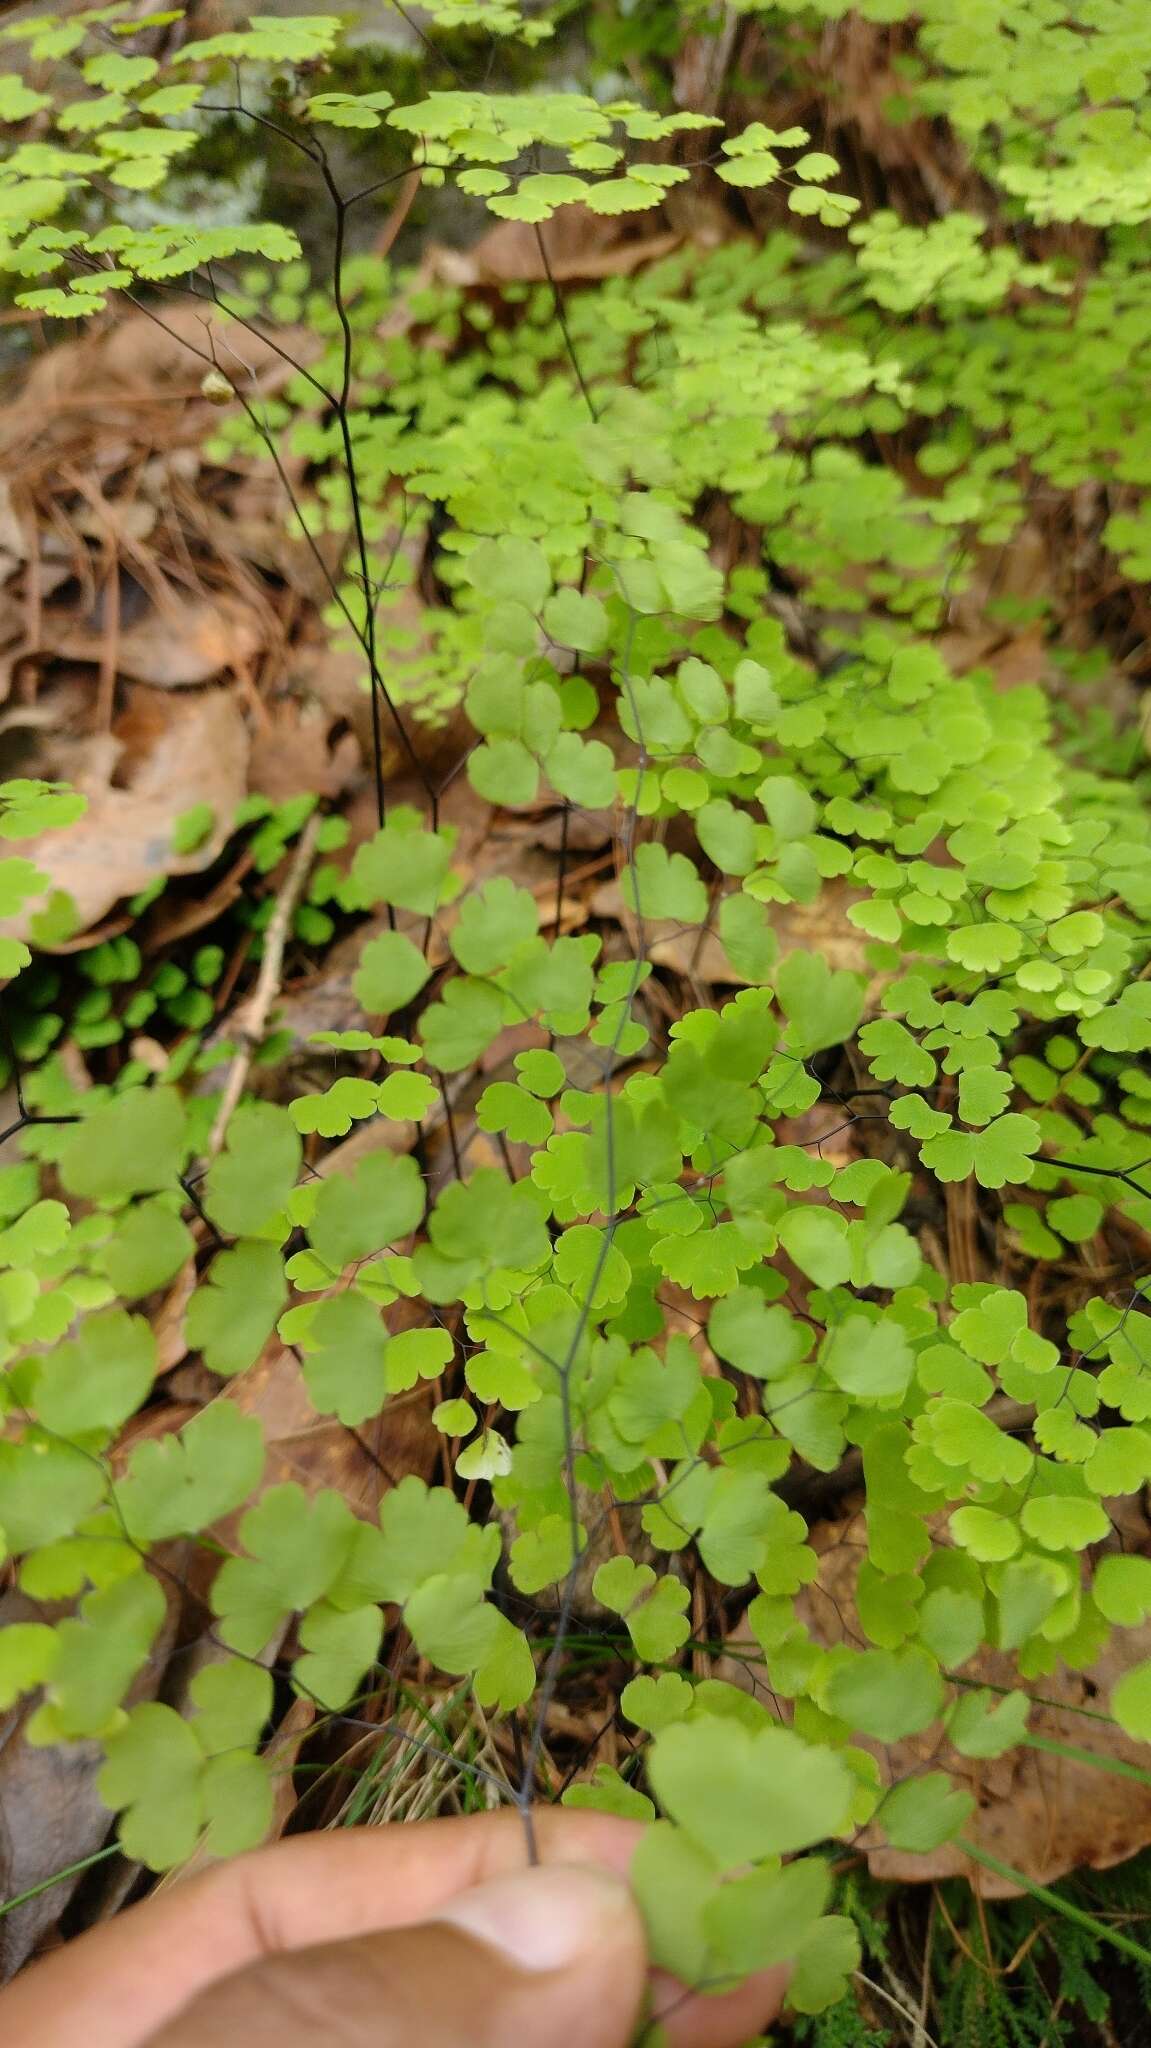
top-left (721, 1513), bottom-right (1151, 1898)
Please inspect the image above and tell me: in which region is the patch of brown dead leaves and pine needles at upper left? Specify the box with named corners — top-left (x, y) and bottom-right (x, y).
top-left (0, 303), bottom-right (434, 950)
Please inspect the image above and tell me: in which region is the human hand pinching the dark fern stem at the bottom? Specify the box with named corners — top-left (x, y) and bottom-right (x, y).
top-left (0, 1808), bottom-right (786, 2048)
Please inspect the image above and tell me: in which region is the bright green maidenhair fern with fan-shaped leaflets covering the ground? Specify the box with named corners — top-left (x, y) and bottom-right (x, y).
top-left (0, 0), bottom-right (1151, 2040)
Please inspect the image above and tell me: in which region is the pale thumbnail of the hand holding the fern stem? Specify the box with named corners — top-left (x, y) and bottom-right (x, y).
top-left (436, 1864), bottom-right (631, 1970)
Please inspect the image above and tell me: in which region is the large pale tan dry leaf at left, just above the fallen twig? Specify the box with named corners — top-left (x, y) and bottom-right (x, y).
top-left (2, 690), bottom-right (248, 950)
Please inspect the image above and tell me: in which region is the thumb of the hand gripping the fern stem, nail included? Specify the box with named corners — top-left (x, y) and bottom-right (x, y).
top-left (150, 1864), bottom-right (647, 2048)
